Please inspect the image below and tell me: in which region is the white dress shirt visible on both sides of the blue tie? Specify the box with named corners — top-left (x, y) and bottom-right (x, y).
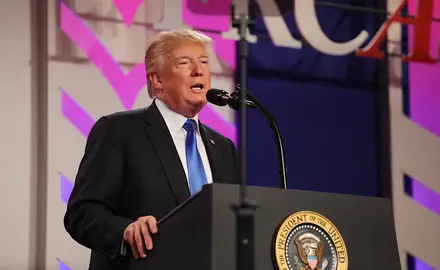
top-left (155, 99), bottom-right (212, 186)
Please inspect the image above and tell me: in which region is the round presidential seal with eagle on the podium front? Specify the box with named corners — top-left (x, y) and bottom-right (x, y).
top-left (273, 211), bottom-right (348, 270)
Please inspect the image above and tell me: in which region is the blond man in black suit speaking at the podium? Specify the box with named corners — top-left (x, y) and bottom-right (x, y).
top-left (64, 30), bottom-right (239, 270)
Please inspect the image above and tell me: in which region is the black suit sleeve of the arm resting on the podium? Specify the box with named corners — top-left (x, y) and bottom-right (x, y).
top-left (64, 117), bottom-right (132, 259)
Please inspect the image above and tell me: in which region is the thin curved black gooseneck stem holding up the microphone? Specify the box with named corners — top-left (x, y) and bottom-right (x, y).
top-left (236, 85), bottom-right (287, 189)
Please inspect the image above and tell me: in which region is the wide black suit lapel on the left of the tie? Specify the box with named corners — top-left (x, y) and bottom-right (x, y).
top-left (141, 102), bottom-right (190, 204)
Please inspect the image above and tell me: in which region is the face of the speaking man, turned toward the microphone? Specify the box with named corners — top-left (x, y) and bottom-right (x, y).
top-left (153, 42), bottom-right (211, 118)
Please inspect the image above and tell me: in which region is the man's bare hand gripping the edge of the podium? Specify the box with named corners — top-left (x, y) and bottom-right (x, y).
top-left (124, 216), bottom-right (157, 259)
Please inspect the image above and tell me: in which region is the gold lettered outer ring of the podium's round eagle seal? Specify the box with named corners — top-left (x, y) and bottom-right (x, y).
top-left (273, 211), bottom-right (348, 270)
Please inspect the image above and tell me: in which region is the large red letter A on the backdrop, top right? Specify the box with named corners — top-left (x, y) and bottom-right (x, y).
top-left (356, 0), bottom-right (435, 63)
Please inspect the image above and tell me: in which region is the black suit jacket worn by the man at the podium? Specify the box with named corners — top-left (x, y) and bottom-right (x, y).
top-left (64, 102), bottom-right (239, 270)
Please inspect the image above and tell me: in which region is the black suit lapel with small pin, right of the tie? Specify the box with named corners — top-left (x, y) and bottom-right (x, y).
top-left (199, 122), bottom-right (226, 183)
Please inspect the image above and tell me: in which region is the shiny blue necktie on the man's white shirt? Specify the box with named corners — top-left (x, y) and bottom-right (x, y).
top-left (183, 119), bottom-right (208, 195)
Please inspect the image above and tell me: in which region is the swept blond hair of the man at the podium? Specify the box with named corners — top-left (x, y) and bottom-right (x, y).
top-left (144, 29), bottom-right (212, 98)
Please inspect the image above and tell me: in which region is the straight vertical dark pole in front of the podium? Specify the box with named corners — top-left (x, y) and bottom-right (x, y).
top-left (231, 0), bottom-right (257, 270)
